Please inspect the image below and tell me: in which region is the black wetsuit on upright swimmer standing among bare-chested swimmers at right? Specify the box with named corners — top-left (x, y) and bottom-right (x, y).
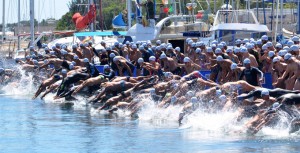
top-left (239, 67), bottom-right (261, 86)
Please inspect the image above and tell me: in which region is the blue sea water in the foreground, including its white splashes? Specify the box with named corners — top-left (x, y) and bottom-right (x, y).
top-left (0, 67), bottom-right (300, 153)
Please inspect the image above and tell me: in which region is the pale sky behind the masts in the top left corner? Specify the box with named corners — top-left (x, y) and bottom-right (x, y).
top-left (0, 0), bottom-right (70, 24)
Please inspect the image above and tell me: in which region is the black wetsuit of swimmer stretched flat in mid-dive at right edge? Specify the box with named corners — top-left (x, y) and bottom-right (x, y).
top-left (237, 88), bottom-right (299, 100)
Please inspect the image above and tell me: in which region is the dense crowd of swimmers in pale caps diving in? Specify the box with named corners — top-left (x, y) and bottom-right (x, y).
top-left (0, 35), bottom-right (300, 134)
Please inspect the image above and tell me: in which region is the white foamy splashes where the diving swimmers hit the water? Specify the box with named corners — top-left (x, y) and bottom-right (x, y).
top-left (1, 58), bottom-right (299, 138)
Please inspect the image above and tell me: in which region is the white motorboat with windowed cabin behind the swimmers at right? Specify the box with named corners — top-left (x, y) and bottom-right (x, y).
top-left (210, 10), bottom-right (270, 46)
